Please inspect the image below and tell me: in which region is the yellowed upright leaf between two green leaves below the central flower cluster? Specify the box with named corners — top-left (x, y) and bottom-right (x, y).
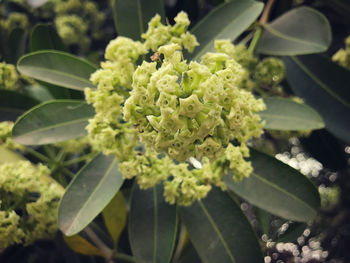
top-left (102, 192), bottom-right (127, 247)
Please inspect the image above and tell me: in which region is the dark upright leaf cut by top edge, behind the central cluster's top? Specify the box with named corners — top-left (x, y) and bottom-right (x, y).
top-left (112, 0), bottom-right (165, 40)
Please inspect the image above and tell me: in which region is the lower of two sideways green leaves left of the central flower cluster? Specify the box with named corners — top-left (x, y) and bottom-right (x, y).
top-left (12, 100), bottom-right (94, 145)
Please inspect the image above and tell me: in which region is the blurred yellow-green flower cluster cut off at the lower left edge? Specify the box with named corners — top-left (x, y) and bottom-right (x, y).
top-left (0, 161), bottom-right (64, 248)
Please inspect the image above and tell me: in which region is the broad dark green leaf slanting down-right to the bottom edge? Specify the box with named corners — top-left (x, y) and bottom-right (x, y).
top-left (179, 188), bottom-right (263, 263)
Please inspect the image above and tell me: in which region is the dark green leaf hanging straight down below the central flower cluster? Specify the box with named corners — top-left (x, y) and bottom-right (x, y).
top-left (129, 182), bottom-right (177, 263)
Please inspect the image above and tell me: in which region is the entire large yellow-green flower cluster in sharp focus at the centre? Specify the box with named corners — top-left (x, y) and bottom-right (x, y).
top-left (85, 12), bottom-right (265, 205)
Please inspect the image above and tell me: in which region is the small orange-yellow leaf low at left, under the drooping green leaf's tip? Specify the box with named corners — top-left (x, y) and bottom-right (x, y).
top-left (63, 235), bottom-right (104, 257)
